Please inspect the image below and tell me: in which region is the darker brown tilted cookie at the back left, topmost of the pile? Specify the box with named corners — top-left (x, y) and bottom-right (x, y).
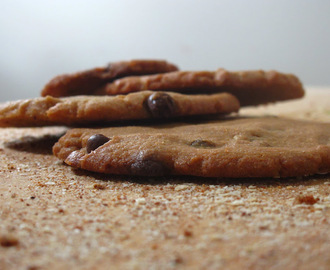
top-left (41, 60), bottom-right (178, 97)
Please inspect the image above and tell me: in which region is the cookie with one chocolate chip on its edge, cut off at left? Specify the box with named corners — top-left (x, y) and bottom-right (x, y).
top-left (0, 91), bottom-right (239, 127)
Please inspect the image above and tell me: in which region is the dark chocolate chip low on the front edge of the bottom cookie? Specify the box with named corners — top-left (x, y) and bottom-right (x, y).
top-left (131, 156), bottom-right (166, 176)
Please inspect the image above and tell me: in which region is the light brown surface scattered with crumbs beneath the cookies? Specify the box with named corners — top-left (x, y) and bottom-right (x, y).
top-left (0, 88), bottom-right (330, 270)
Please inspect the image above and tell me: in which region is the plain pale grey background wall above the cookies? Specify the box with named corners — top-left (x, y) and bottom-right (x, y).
top-left (0, 0), bottom-right (330, 101)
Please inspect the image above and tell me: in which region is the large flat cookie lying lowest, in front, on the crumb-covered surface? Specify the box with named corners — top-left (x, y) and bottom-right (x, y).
top-left (53, 117), bottom-right (330, 178)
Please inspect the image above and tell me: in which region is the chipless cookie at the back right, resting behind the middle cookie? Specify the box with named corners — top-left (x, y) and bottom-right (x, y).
top-left (96, 69), bottom-right (304, 106)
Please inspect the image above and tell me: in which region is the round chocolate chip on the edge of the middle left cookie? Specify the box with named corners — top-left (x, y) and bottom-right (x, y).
top-left (147, 92), bottom-right (176, 118)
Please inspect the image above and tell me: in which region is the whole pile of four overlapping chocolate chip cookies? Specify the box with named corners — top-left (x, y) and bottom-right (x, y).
top-left (0, 60), bottom-right (330, 178)
